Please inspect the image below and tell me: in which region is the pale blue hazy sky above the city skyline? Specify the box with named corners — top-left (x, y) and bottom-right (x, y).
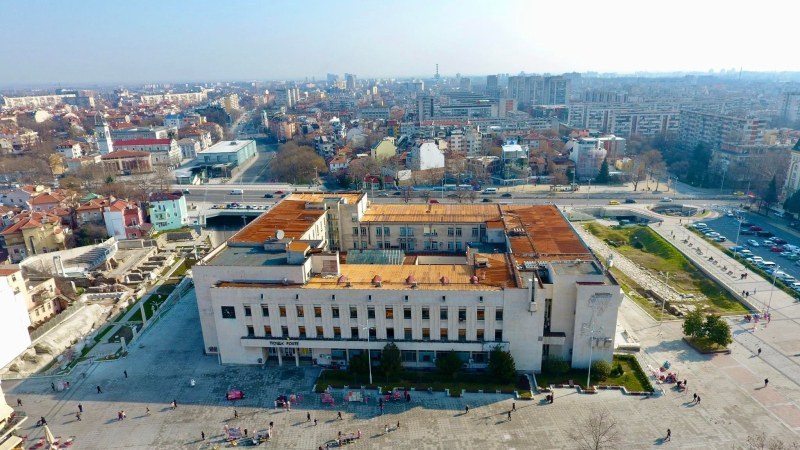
top-left (0, 0), bottom-right (800, 85)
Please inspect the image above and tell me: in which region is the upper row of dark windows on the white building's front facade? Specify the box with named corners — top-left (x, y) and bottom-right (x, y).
top-left (227, 304), bottom-right (503, 322)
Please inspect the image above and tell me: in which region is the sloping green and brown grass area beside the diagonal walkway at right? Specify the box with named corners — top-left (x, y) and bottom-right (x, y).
top-left (586, 223), bottom-right (747, 314)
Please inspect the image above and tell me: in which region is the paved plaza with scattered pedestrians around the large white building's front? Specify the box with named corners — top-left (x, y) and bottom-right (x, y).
top-left (3, 210), bottom-right (800, 449)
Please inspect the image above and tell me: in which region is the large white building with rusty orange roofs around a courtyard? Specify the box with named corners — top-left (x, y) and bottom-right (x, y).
top-left (193, 193), bottom-right (621, 371)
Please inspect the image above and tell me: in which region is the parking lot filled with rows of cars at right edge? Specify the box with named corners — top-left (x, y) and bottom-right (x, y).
top-left (692, 211), bottom-right (800, 292)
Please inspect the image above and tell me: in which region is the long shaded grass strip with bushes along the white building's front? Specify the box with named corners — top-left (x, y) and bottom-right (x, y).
top-left (317, 370), bottom-right (522, 393)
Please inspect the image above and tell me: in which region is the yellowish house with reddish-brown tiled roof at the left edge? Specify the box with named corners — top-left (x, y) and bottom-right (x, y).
top-left (0, 211), bottom-right (68, 263)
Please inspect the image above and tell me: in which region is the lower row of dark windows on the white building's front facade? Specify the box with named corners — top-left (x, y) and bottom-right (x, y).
top-left (247, 325), bottom-right (503, 342)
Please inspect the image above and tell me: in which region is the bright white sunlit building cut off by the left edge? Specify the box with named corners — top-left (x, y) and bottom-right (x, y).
top-left (0, 265), bottom-right (31, 372)
